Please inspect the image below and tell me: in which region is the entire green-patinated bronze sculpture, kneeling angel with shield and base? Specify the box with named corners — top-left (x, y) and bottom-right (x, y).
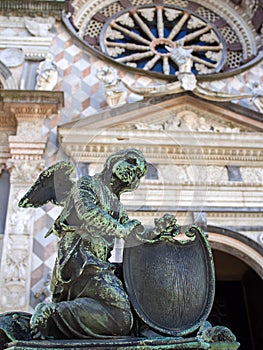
top-left (0, 149), bottom-right (239, 350)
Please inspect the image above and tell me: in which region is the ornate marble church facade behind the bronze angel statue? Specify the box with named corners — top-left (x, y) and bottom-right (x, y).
top-left (0, 0), bottom-right (263, 350)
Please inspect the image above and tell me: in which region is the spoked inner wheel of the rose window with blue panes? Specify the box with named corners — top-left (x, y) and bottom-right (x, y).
top-left (101, 6), bottom-right (225, 75)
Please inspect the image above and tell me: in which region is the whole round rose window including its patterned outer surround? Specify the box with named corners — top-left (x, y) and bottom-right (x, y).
top-left (64, 0), bottom-right (263, 79)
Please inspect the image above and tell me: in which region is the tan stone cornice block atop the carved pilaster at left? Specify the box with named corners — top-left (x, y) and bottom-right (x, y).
top-left (0, 90), bottom-right (64, 164)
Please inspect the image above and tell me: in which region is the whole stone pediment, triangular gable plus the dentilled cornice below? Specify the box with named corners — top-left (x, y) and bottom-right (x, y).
top-left (58, 92), bottom-right (263, 166)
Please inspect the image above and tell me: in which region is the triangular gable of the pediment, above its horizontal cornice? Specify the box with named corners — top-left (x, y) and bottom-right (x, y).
top-left (60, 92), bottom-right (263, 132)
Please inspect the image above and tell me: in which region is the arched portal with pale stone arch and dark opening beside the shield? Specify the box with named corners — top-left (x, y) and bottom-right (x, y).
top-left (208, 227), bottom-right (263, 350)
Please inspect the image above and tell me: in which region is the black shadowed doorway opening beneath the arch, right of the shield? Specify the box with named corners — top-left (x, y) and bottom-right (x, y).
top-left (208, 250), bottom-right (263, 350)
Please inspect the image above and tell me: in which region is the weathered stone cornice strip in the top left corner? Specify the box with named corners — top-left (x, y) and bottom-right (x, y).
top-left (0, 0), bottom-right (67, 20)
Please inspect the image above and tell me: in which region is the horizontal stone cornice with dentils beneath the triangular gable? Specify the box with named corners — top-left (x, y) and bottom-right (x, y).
top-left (60, 129), bottom-right (263, 166)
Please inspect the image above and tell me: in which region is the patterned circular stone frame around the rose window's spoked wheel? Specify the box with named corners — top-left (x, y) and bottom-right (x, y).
top-left (62, 0), bottom-right (263, 81)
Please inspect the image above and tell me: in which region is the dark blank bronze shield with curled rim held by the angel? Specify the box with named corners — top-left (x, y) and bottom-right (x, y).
top-left (123, 225), bottom-right (215, 336)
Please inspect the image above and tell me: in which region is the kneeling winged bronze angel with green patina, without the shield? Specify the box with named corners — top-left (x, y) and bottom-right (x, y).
top-left (0, 149), bottom-right (180, 348)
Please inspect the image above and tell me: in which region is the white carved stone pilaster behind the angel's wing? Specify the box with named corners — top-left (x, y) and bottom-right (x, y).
top-left (0, 159), bottom-right (44, 311)
